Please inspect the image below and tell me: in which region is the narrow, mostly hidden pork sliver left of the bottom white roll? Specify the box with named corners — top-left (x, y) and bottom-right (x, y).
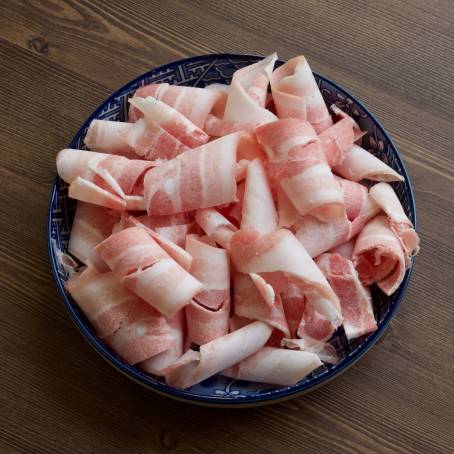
top-left (140, 311), bottom-right (184, 376)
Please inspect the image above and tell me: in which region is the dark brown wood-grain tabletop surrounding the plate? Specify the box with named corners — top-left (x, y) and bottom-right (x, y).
top-left (0, 0), bottom-right (454, 454)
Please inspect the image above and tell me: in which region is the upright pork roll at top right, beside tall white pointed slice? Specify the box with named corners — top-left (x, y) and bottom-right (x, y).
top-left (271, 55), bottom-right (333, 133)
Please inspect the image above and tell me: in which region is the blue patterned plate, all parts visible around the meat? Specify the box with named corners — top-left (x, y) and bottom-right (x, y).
top-left (48, 54), bottom-right (416, 406)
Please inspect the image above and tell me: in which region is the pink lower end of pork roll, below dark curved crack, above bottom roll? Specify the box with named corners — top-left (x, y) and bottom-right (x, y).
top-left (185, 297), bottom-right (230, 345)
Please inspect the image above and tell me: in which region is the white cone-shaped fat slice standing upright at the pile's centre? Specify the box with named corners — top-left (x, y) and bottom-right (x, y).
top-left (241, 158), bottom-right (278, 233)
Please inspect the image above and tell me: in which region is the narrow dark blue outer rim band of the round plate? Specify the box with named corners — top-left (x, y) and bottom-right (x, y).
top-left (46, 53), bottom-right (417, 408)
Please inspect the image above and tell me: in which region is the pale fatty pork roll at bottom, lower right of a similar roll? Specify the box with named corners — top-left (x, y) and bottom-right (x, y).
top-left (221, 347), bottom-right (322, 386)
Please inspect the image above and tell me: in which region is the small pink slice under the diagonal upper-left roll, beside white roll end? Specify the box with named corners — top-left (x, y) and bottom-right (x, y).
top-left (124, 119), bottom-right (190, 161)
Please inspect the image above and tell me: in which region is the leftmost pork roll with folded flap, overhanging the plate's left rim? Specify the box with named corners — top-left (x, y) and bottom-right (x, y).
top-left (57, 149), bottom-right (154, 210)
